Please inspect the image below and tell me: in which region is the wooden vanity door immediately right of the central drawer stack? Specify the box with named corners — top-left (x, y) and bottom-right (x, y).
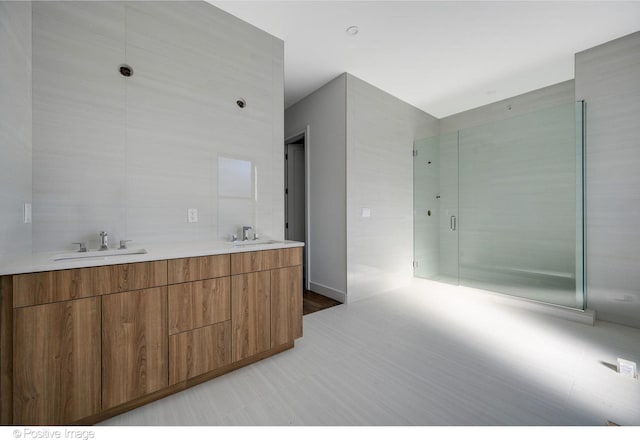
top-left (231, 271), bottom-right (271, 362)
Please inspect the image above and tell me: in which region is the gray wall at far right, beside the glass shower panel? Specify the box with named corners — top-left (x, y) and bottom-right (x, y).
top-left (575, 32), bottom-right (640, 327)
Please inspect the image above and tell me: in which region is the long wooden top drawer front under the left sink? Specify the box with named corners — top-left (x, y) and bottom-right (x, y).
top-left (13, 261), bottom-right (167, 307)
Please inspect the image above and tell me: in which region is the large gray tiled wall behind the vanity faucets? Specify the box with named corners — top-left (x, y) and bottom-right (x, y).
top-left (27, 2), bottom-right (284, 252)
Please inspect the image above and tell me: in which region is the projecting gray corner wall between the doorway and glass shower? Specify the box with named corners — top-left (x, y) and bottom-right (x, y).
top-left (285, 74), bottom-right (438, 302)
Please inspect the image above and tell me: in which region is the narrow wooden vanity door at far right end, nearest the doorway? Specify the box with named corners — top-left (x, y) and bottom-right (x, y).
top-left (271, 266), bottom-right (302, 347)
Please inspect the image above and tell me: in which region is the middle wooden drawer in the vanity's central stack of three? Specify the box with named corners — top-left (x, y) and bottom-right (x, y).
top-left (169, 277), bottom-right (231, 335)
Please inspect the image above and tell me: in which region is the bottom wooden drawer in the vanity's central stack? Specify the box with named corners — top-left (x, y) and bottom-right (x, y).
top-left (169, 321), bottom-right (231, 385)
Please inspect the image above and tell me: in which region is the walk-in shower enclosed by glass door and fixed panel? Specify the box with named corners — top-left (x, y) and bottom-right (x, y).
top-left (414, 102), bottom-right (585, 309)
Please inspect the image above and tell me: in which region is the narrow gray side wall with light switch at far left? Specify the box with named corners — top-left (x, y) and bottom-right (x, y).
top-left (0, 2), bottom-right (32, 259)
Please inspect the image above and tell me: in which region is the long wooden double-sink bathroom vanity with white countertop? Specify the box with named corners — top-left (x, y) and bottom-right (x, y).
top-left (0, 242), bottom-right (303, 425)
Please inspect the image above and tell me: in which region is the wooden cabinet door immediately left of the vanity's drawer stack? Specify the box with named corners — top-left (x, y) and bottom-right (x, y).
top-left (102, 287), bottom-right (168, 409)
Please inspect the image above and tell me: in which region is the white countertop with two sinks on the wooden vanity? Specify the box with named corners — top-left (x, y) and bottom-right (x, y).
top-left (0, 239), bottom-right (304, 275)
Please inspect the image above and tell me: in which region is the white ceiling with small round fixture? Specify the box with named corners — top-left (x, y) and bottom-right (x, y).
top-left (208, 0), bottom-right (640, 118)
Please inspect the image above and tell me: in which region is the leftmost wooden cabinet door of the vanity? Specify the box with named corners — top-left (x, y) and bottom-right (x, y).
top-left (13, 298), bottom-right (100, 425)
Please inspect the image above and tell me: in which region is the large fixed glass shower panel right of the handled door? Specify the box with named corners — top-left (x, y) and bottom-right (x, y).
top-left (458, 103), bottom-right (583, 308)
